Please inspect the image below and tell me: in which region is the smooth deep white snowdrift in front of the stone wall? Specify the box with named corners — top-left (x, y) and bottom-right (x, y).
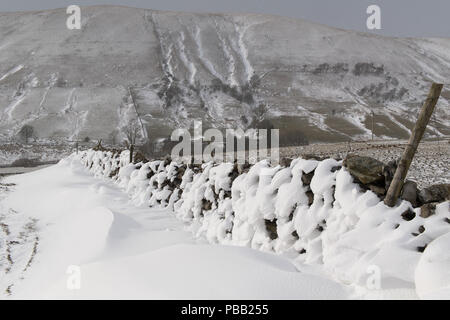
top-left (0, 156), bottom-right (450, 299)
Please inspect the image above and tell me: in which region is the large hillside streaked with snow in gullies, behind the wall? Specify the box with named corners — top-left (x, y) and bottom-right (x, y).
top-left (0, 6), bottom-right (450, 147)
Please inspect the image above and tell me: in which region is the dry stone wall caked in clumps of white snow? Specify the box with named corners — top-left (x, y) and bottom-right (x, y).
top-left (72, 150), bottom-right (450, 295)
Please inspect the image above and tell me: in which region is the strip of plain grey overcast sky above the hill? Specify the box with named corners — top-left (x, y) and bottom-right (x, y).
top-left (0, 0), bottom-right (450, 38)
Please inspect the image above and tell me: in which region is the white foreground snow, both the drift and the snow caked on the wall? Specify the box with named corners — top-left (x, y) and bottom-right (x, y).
top-left (0, 150), bottom-right (450, 299)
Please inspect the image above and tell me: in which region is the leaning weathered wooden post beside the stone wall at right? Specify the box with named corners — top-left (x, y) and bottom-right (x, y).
top-left (384, 83), bottom-right (443, 207)
